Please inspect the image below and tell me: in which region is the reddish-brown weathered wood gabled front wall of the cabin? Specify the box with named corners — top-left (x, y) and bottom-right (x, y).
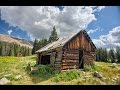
top-left (61, 32), bottom-right (95, 70)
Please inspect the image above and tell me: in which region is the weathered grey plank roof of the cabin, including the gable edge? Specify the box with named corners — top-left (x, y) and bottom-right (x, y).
top-left (36, 30), bottom-right (96, 53)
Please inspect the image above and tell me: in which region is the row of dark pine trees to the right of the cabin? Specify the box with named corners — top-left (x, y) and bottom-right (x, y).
top-left (96, 46), bottom-right (120, 63)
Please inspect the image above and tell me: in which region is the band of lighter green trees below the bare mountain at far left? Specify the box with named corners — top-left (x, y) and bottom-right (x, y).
top-left (0, 42), bottom-right (32, 56)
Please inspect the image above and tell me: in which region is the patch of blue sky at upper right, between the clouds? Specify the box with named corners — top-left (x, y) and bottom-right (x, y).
top-left (87, 6), bottom-right (120, 39)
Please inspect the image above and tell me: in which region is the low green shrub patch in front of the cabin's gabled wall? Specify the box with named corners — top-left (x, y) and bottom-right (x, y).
top-left (53, 69), bottom-right (81, 82)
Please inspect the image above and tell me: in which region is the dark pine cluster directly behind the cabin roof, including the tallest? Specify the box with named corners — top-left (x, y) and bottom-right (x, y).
top-left (32, 26), bottom-right (59, 54)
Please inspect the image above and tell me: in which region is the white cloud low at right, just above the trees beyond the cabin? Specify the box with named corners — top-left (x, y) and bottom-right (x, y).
top-left (93, 26), bottom-right (120, 47)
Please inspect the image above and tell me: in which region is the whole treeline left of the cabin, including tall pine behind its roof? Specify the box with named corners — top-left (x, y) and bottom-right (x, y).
top-left (0, 26), bottom-right (59, 56)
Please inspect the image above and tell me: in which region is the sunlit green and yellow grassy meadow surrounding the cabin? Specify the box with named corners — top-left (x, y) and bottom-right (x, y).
top-left (0, 55), bottom-right (120, 85)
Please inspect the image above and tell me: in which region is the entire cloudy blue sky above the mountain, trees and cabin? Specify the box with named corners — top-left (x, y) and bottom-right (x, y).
top-left (0, 6), bottom-right (120, 48)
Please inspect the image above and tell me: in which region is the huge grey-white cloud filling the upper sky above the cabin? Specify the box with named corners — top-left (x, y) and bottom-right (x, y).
top-left (1, 6), bottom-right (103, 38)
